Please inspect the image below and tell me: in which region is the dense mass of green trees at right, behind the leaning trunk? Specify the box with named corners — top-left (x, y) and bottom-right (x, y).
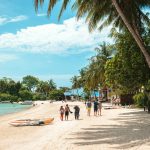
top-left (71, 29), bottom-right (150, 106)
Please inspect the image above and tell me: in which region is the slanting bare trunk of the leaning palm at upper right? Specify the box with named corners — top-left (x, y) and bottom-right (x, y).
top-left (112, 0), bottom-right (150, 68)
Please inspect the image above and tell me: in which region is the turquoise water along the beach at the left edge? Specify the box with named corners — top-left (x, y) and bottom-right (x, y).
top-left (0, 103), bottom-right (31, 115)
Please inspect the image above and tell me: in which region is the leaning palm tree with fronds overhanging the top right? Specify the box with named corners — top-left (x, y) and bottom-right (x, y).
top-left (35, 0), bottom-right (150, 67)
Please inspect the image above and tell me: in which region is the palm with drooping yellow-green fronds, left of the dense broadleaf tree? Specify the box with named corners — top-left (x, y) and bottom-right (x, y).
top-left (79, 42), bottom-right (111, 98)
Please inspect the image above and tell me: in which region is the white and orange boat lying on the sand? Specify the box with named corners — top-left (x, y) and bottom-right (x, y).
top-left (9, 118), bottom-right (54, 127)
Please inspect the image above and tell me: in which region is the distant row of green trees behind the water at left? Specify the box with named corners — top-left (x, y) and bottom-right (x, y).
top-left (0, 75), bottom-right (62, 102)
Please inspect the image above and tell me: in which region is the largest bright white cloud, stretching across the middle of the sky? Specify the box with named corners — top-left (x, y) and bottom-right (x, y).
top-left (0, 18), bottom-right (110, 54)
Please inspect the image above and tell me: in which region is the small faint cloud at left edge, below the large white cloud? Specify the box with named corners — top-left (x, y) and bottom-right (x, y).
top-left (0, 54), bottom-right (18, 63)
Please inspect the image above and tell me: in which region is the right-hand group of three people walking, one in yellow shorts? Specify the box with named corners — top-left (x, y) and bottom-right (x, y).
top-left (86, 100), bottom-right (102, 116)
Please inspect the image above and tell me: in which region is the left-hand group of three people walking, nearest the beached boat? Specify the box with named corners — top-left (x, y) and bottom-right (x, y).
top-left (60, 104), bottom-right (80, 121)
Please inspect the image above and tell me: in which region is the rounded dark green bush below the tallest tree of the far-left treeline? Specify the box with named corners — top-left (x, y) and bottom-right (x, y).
top-left (19, 90), bottom-right (33, 100)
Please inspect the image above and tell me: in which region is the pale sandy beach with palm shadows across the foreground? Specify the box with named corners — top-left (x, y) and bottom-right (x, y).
top-left (0, 102), bottom-right (150, 150)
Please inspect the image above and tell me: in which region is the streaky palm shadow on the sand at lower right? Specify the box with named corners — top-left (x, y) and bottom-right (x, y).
top-left (67, 111), bottom-right (150, 149)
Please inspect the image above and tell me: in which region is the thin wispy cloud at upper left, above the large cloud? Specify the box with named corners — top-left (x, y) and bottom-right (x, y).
top-left (0, 15), bottom-right (27, 25)
